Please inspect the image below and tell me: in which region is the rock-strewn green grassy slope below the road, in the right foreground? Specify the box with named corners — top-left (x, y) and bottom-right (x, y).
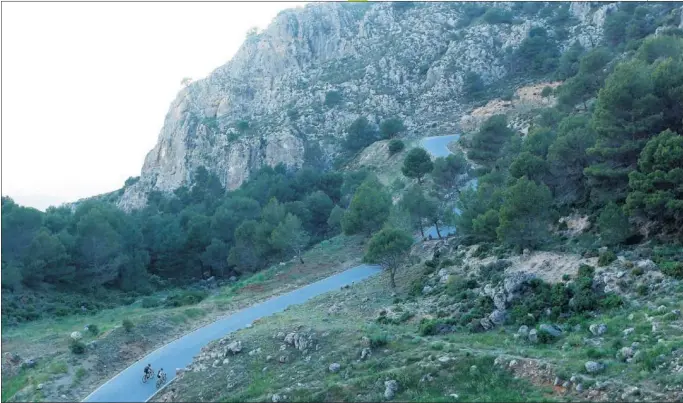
top-left (156, 243), bottom-right (683, 401)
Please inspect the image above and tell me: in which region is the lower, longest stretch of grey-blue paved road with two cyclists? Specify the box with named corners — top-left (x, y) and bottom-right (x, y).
top-left (83, 265), bottom-right (381, 402)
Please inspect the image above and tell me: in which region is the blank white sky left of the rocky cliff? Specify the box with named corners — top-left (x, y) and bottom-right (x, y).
top-left (2, 3), bottom-right (304, 209)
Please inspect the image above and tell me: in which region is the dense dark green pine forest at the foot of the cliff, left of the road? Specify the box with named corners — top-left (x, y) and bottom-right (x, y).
top-left (2, 165), bottom-right (390, 322)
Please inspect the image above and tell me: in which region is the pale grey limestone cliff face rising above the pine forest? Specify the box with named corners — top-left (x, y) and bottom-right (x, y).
top-left (118, 3), bottom-right (615, 210)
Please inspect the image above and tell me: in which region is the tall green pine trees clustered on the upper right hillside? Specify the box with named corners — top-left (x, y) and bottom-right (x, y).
top-left (457, 35), bottom-right (683, 247)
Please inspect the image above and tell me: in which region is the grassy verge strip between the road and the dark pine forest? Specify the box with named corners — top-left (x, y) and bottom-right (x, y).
top-left (2, 236), bottom-right (362, 401)
